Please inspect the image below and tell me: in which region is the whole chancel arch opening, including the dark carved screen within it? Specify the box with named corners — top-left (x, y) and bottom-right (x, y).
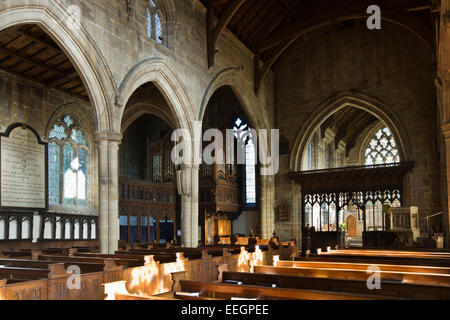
top-left (290, 92), bottom-right (413, 250)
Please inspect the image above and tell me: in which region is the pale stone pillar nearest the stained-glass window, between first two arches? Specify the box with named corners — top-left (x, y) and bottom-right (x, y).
top-left (96, 132), bottom-right (122, 253)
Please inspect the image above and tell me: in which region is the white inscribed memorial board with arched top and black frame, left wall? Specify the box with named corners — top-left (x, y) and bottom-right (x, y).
top-left (0, 124), bottom-right (48, 209)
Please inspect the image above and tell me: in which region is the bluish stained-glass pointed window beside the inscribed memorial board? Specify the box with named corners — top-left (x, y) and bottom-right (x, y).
top-left (48, 115), bottom-right (89, 206)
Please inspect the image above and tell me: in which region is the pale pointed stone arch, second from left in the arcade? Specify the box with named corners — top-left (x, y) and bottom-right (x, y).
top-left (116, 58), bottom-right (195, 134)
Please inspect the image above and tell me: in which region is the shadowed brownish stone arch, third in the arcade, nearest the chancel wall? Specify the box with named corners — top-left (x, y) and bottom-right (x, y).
top-left (197, 67), bottom-right (270, 129)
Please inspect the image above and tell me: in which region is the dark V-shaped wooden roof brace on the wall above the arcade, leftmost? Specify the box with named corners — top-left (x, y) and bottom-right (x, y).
top-left (206, 0), bottom-right (245, 68)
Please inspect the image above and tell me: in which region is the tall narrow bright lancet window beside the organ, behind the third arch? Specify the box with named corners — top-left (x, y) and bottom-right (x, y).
top-left (233, 118), bottom-right (256, 206)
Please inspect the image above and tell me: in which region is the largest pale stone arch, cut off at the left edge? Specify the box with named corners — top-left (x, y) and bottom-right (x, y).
top-left (0, 0), bottom-right (117, 132)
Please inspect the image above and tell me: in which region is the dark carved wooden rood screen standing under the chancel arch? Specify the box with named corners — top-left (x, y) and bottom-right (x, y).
top-left (289, 163), bottom-right (413, 232)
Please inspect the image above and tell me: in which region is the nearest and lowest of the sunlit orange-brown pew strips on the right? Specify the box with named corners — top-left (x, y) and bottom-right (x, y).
top-left (254, 266), bottom-right (450, 286)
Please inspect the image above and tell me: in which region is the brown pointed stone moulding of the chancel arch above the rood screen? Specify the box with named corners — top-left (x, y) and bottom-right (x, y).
top-left (289, 92), bottom-right (412, 171)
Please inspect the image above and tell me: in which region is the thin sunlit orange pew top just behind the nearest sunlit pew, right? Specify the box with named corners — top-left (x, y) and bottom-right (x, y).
top-left (277, 260), bottom-right (450, 274)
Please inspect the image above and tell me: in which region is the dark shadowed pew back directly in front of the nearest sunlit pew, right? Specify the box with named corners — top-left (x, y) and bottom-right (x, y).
top-left (222, 272), bottom-right (450, 300)
